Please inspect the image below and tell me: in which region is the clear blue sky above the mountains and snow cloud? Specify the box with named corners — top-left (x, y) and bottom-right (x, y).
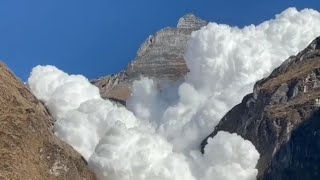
top-left (0, 0), bottom-right (320, 80)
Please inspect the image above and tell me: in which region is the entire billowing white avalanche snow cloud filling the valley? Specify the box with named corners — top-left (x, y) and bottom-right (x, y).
top-left (28, 8), bottom-right (320, 180)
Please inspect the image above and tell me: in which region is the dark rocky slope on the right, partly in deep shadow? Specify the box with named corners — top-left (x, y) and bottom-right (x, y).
top-left (201, 38), bottom-right (320, 180)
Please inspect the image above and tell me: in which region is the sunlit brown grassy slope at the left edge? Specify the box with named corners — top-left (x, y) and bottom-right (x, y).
top-left (0, 63), bottom-right (95, 180)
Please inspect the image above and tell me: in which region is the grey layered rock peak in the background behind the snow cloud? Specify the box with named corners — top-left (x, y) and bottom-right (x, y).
top-left (92, 14), bottom-right (207, 101)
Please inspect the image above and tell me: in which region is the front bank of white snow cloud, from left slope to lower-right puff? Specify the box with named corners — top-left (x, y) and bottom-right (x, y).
top-left (29, 66), bottom-right (259, 180)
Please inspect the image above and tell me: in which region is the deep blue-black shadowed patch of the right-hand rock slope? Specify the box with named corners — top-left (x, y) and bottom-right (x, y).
top-left (264, 111), bottom-right (320, 180)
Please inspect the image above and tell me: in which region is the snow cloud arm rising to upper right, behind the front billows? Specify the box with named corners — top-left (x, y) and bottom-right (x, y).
top-left (128, 8), bottom-right (320, 151)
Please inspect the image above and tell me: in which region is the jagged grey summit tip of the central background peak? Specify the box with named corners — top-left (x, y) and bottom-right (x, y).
top-left (177, 13), bottom-right (207, 29)
